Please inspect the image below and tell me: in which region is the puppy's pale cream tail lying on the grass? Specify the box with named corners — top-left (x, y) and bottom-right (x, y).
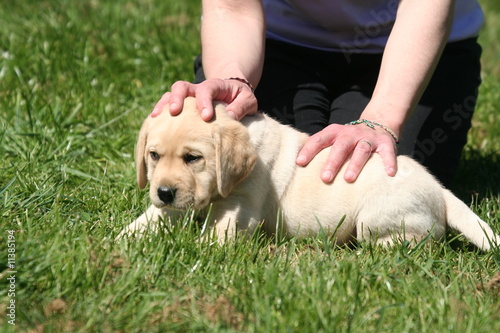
top-left (443, 189), bottom-right (500, 251)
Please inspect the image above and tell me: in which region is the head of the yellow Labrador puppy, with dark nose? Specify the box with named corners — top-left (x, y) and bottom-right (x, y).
top-left (135, 97), bottom-right (256, 209)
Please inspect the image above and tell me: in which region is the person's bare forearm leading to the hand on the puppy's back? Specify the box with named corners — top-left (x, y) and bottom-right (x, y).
top-left (362, 0), bottom-right (455, 134)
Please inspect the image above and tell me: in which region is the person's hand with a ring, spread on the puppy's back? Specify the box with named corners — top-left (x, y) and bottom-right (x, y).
top-left (296, 124), bottom-right (397, 183)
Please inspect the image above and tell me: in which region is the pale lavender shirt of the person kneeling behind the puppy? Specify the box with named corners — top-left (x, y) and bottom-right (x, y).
top-left (263, 0), bottom-right (484, 53)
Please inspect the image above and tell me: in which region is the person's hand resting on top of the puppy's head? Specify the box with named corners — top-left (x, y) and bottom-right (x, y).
top-left (151, 79), bottom-right (257, 121)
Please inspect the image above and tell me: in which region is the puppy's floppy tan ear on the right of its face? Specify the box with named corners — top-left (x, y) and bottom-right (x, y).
top-left (212, 120), bottom-right (257, 198)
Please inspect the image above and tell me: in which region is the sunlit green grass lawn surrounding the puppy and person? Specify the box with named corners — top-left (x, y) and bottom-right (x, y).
top-left (0, 0), bottom-right (500, 333)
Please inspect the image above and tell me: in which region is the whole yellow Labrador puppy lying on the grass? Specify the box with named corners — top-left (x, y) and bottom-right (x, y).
top-left (121, 98), bottom-right (500, 250)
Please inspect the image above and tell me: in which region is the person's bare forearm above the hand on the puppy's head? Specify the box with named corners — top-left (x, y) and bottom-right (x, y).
top-left (201, 0), bottom-right (265, 87)
